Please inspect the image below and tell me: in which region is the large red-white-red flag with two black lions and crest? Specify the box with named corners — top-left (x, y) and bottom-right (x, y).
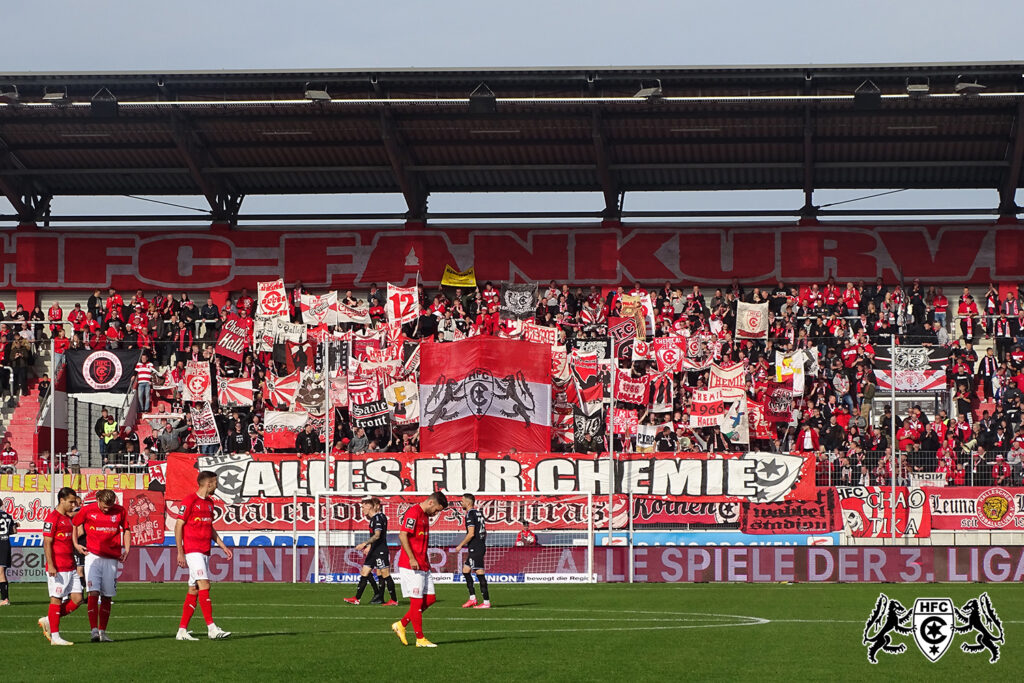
top-left (420, 336), bottom-right (551, 452)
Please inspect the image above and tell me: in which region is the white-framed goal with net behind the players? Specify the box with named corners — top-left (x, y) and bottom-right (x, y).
top-left (309, 493), bottom-right (603, 583)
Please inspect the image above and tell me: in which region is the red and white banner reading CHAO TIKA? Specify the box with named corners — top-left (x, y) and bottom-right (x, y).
top-left (836, 486), bottom-right (932, 539)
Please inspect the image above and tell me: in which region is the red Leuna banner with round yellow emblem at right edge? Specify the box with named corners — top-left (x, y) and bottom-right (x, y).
top-left (922, 486), bottom-right (1024, 532)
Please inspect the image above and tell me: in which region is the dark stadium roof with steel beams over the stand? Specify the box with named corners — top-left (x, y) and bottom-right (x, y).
top-left (0, 62), bottom-right (1024, 220)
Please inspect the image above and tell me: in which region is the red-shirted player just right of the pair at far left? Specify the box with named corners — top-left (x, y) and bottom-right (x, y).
top-left (174, 472), bottom-right (231, 640)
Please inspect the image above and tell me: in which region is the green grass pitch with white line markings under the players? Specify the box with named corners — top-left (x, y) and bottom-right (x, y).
top-left (0, 584), bottom-right (1024, 682)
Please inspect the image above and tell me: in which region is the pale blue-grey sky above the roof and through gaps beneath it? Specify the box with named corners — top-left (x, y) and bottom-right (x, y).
top-left (0, 0), bottom-right (1024, 220)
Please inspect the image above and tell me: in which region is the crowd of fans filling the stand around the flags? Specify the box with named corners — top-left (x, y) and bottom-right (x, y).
top-left (0, 279), bottom-right (1024, 485)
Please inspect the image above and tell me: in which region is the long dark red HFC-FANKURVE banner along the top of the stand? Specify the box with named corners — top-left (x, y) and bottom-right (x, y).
top-left (8, 222), bottom-right (1024, 290)
